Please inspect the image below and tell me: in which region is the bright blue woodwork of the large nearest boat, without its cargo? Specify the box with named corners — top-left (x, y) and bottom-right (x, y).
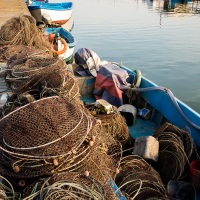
top-left (75, 62), bottom-right (200, 199)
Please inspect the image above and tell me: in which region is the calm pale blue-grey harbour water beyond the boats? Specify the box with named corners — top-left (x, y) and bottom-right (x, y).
top-left (52, 0), bottom-right (200, 112)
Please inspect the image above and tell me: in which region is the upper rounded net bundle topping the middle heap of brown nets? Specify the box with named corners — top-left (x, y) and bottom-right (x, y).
top-left (5, 54), bottom-right (66, 93)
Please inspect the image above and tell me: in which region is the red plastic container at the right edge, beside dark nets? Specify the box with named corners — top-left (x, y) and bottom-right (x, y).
top-left (190, 160), bottom-right (200, 191)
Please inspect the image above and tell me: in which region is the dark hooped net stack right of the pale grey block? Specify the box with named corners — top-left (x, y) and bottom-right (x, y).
top-left (153, 122), bottom-right (198, 184)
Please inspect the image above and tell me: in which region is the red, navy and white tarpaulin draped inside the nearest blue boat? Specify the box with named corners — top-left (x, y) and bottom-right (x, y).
top-left (93, 63), bottom-right (130, 107)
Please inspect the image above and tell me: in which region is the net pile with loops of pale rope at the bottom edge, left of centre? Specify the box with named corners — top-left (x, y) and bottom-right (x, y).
top-left (23, 172), bottom-right (118, 200)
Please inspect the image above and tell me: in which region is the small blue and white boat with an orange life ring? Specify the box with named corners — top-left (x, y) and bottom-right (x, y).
top-left (45, 27), bottom-right (76, 63)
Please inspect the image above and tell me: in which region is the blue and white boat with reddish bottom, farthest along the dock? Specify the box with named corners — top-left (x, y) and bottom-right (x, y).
top-left (28, 1), bottom-right (73, 25)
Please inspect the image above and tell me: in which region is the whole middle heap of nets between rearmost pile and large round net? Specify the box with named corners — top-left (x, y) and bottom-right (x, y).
top-left (0, 52), bottom-right (83, 118)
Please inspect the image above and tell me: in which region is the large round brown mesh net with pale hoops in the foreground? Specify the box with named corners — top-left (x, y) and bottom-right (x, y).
top-left (0, 97), bottom-right (96, 178)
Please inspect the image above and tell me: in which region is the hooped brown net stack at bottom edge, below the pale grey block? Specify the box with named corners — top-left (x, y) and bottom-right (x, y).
top-left (115, 155), bottom-right (170, 200)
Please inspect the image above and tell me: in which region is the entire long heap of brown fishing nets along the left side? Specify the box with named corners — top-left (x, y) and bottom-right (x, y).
top-left (0, 15), bottom-right (128, 200)
